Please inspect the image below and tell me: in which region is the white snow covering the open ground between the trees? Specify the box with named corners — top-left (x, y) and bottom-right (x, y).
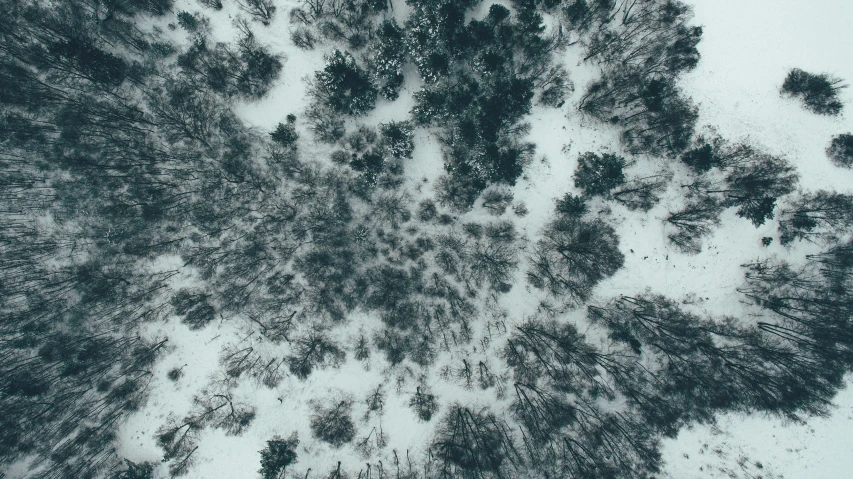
top-left (98, 0), bottom-right (853, 479)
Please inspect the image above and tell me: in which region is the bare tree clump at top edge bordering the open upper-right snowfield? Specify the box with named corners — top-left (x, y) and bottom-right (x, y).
top-left (562, 0), bottom-right (702, 157)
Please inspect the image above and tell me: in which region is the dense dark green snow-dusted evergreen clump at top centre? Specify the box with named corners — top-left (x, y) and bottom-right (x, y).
top-left (406, 1), bottom-right (569, 210)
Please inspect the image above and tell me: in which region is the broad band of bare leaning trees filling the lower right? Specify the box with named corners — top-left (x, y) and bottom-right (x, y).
top-left (486, 268), bottom-right (853, 478)
